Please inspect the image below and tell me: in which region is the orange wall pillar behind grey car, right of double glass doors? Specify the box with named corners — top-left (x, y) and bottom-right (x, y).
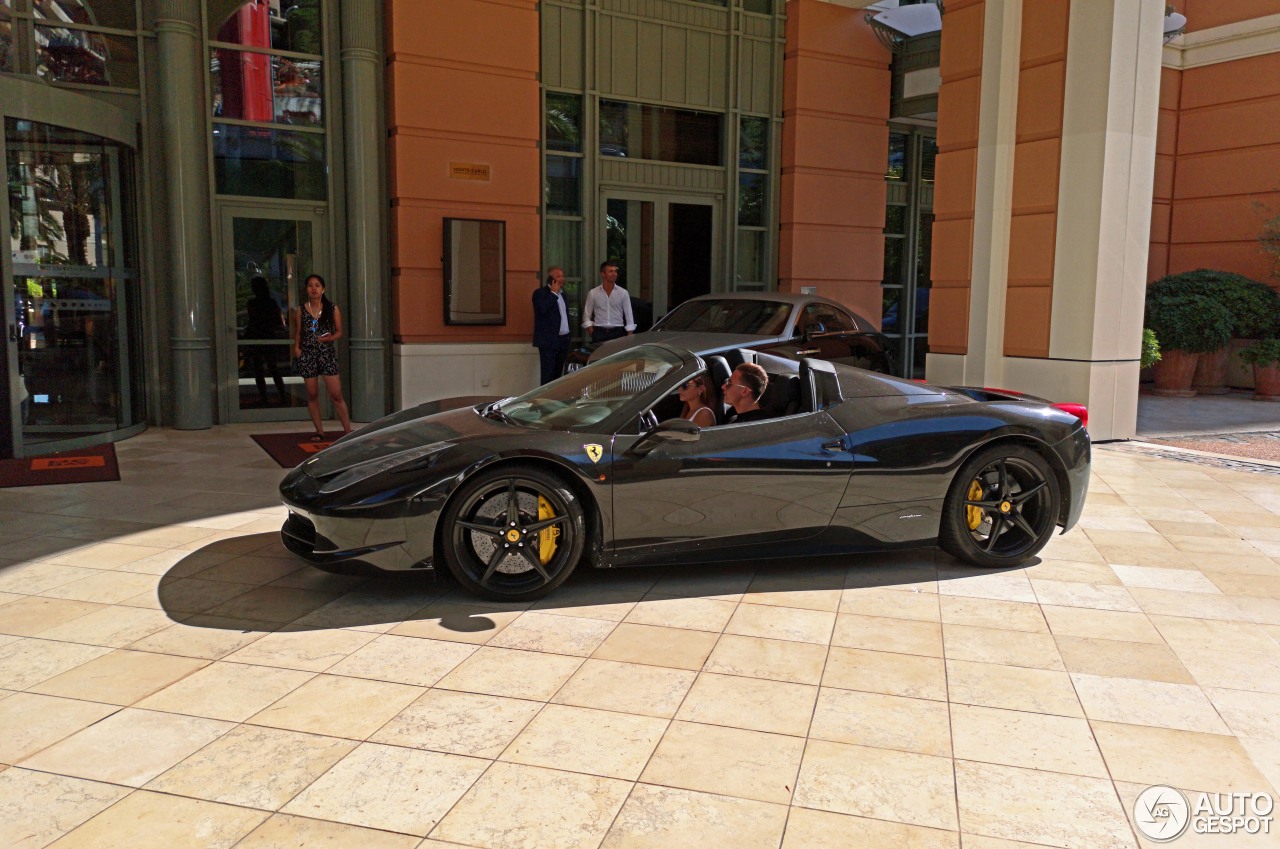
top-left (778, 0), bottom-right (890, 320)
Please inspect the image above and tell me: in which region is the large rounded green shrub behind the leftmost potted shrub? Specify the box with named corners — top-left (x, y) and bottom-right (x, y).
top-left (1147, 269), bottom-right (1280, 394)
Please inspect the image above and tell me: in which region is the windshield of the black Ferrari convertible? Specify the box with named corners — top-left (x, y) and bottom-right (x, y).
top-left (486, 344), bottom-right (684, 430)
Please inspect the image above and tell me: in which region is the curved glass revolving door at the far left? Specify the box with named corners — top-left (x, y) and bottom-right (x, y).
top-left (4, 118), bottom-right (142, 456)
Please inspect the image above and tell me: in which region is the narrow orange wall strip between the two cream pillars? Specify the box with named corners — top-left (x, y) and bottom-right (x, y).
top-left (1004, 0), bottom-right (1070, 357)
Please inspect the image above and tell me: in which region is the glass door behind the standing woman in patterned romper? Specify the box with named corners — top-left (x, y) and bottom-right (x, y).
top-left (219, 206), bottom-right (325, 421)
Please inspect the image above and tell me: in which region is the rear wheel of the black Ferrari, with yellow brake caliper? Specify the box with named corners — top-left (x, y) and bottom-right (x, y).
top-left (938, 444), bottom-right (1062, 569)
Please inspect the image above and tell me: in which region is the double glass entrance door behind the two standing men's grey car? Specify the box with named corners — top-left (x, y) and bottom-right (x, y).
top-left (593, 192), bottom-right (718, 330)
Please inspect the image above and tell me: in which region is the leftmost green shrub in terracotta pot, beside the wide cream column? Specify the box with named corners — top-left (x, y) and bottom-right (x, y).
top-left (1146, 293), bottom-right (1233, 398)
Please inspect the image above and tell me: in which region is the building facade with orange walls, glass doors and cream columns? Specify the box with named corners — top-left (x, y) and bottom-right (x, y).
top-left (0, 0), bottom-right (1280, 456)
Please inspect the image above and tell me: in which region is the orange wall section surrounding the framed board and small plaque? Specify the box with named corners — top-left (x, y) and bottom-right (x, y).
top-left (387, 0), bottom-right (541, 342)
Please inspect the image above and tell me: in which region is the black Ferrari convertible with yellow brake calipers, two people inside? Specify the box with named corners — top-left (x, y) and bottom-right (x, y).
top-left (280, 344), bottom-right (1089, 599)
